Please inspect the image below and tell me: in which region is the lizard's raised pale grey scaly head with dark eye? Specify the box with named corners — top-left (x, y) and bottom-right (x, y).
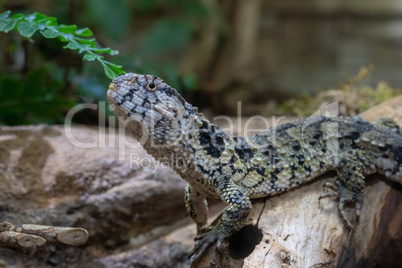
top-left (107, 73), bottom-right (195, 144)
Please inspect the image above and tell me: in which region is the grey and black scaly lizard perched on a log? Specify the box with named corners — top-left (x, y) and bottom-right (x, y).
top-left (107, 73), bottom-right (402, 262)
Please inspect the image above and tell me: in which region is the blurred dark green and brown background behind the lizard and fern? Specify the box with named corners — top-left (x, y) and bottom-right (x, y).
top-left (0, 0), bottom-right (402, 125)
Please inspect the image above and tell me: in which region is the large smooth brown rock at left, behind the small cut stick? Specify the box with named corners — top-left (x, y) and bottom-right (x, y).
top-left (0, 125), bottom-right (191, 265)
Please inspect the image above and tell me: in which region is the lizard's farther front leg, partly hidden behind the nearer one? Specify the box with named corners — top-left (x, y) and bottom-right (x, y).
top-left (184, 183), bottom-right (208, 235)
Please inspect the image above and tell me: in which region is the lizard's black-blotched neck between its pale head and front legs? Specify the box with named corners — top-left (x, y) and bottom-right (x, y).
top-left (139, 103), bottom-right (237, 180)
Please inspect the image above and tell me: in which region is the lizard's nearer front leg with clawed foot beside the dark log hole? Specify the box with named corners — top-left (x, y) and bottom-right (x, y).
top-left (190, 177), bottom-right (251, 262)
